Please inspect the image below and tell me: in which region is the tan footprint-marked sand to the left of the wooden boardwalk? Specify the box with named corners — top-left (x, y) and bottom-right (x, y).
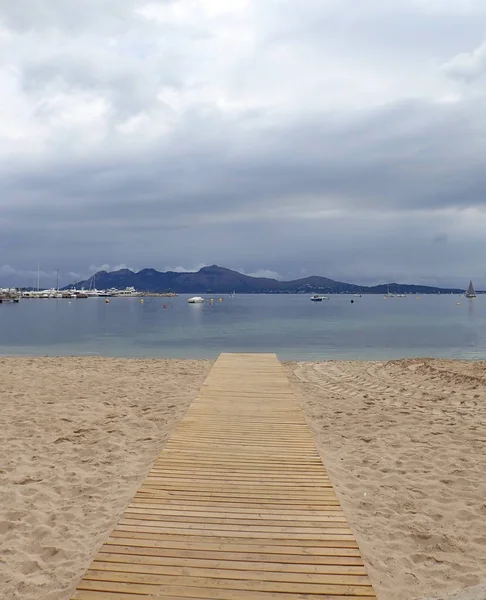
top-left (0, 358), bottom-right (212, 600)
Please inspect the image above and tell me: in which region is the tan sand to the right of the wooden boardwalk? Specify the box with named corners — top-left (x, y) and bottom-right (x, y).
top-left (287, 359), bottom-right (486, 600)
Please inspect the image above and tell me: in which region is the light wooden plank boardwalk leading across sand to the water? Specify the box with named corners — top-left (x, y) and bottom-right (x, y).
top-left (72, 354), bottom-right (376, 600)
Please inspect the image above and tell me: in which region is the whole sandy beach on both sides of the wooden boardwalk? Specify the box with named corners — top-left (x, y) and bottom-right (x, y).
top-left (0, 358), bottom-right (486, 600)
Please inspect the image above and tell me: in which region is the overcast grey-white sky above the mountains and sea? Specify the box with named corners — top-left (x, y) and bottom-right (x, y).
top-left (0, 0), bottom-right (486, 288)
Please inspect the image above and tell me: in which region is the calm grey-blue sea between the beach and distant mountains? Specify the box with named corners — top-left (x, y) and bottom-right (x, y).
top-left (0, 295), bottom-right (486, 360)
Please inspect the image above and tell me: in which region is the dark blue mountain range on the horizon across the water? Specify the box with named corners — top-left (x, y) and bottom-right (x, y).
top-left (69, 265), bottom-right (464, 294)
